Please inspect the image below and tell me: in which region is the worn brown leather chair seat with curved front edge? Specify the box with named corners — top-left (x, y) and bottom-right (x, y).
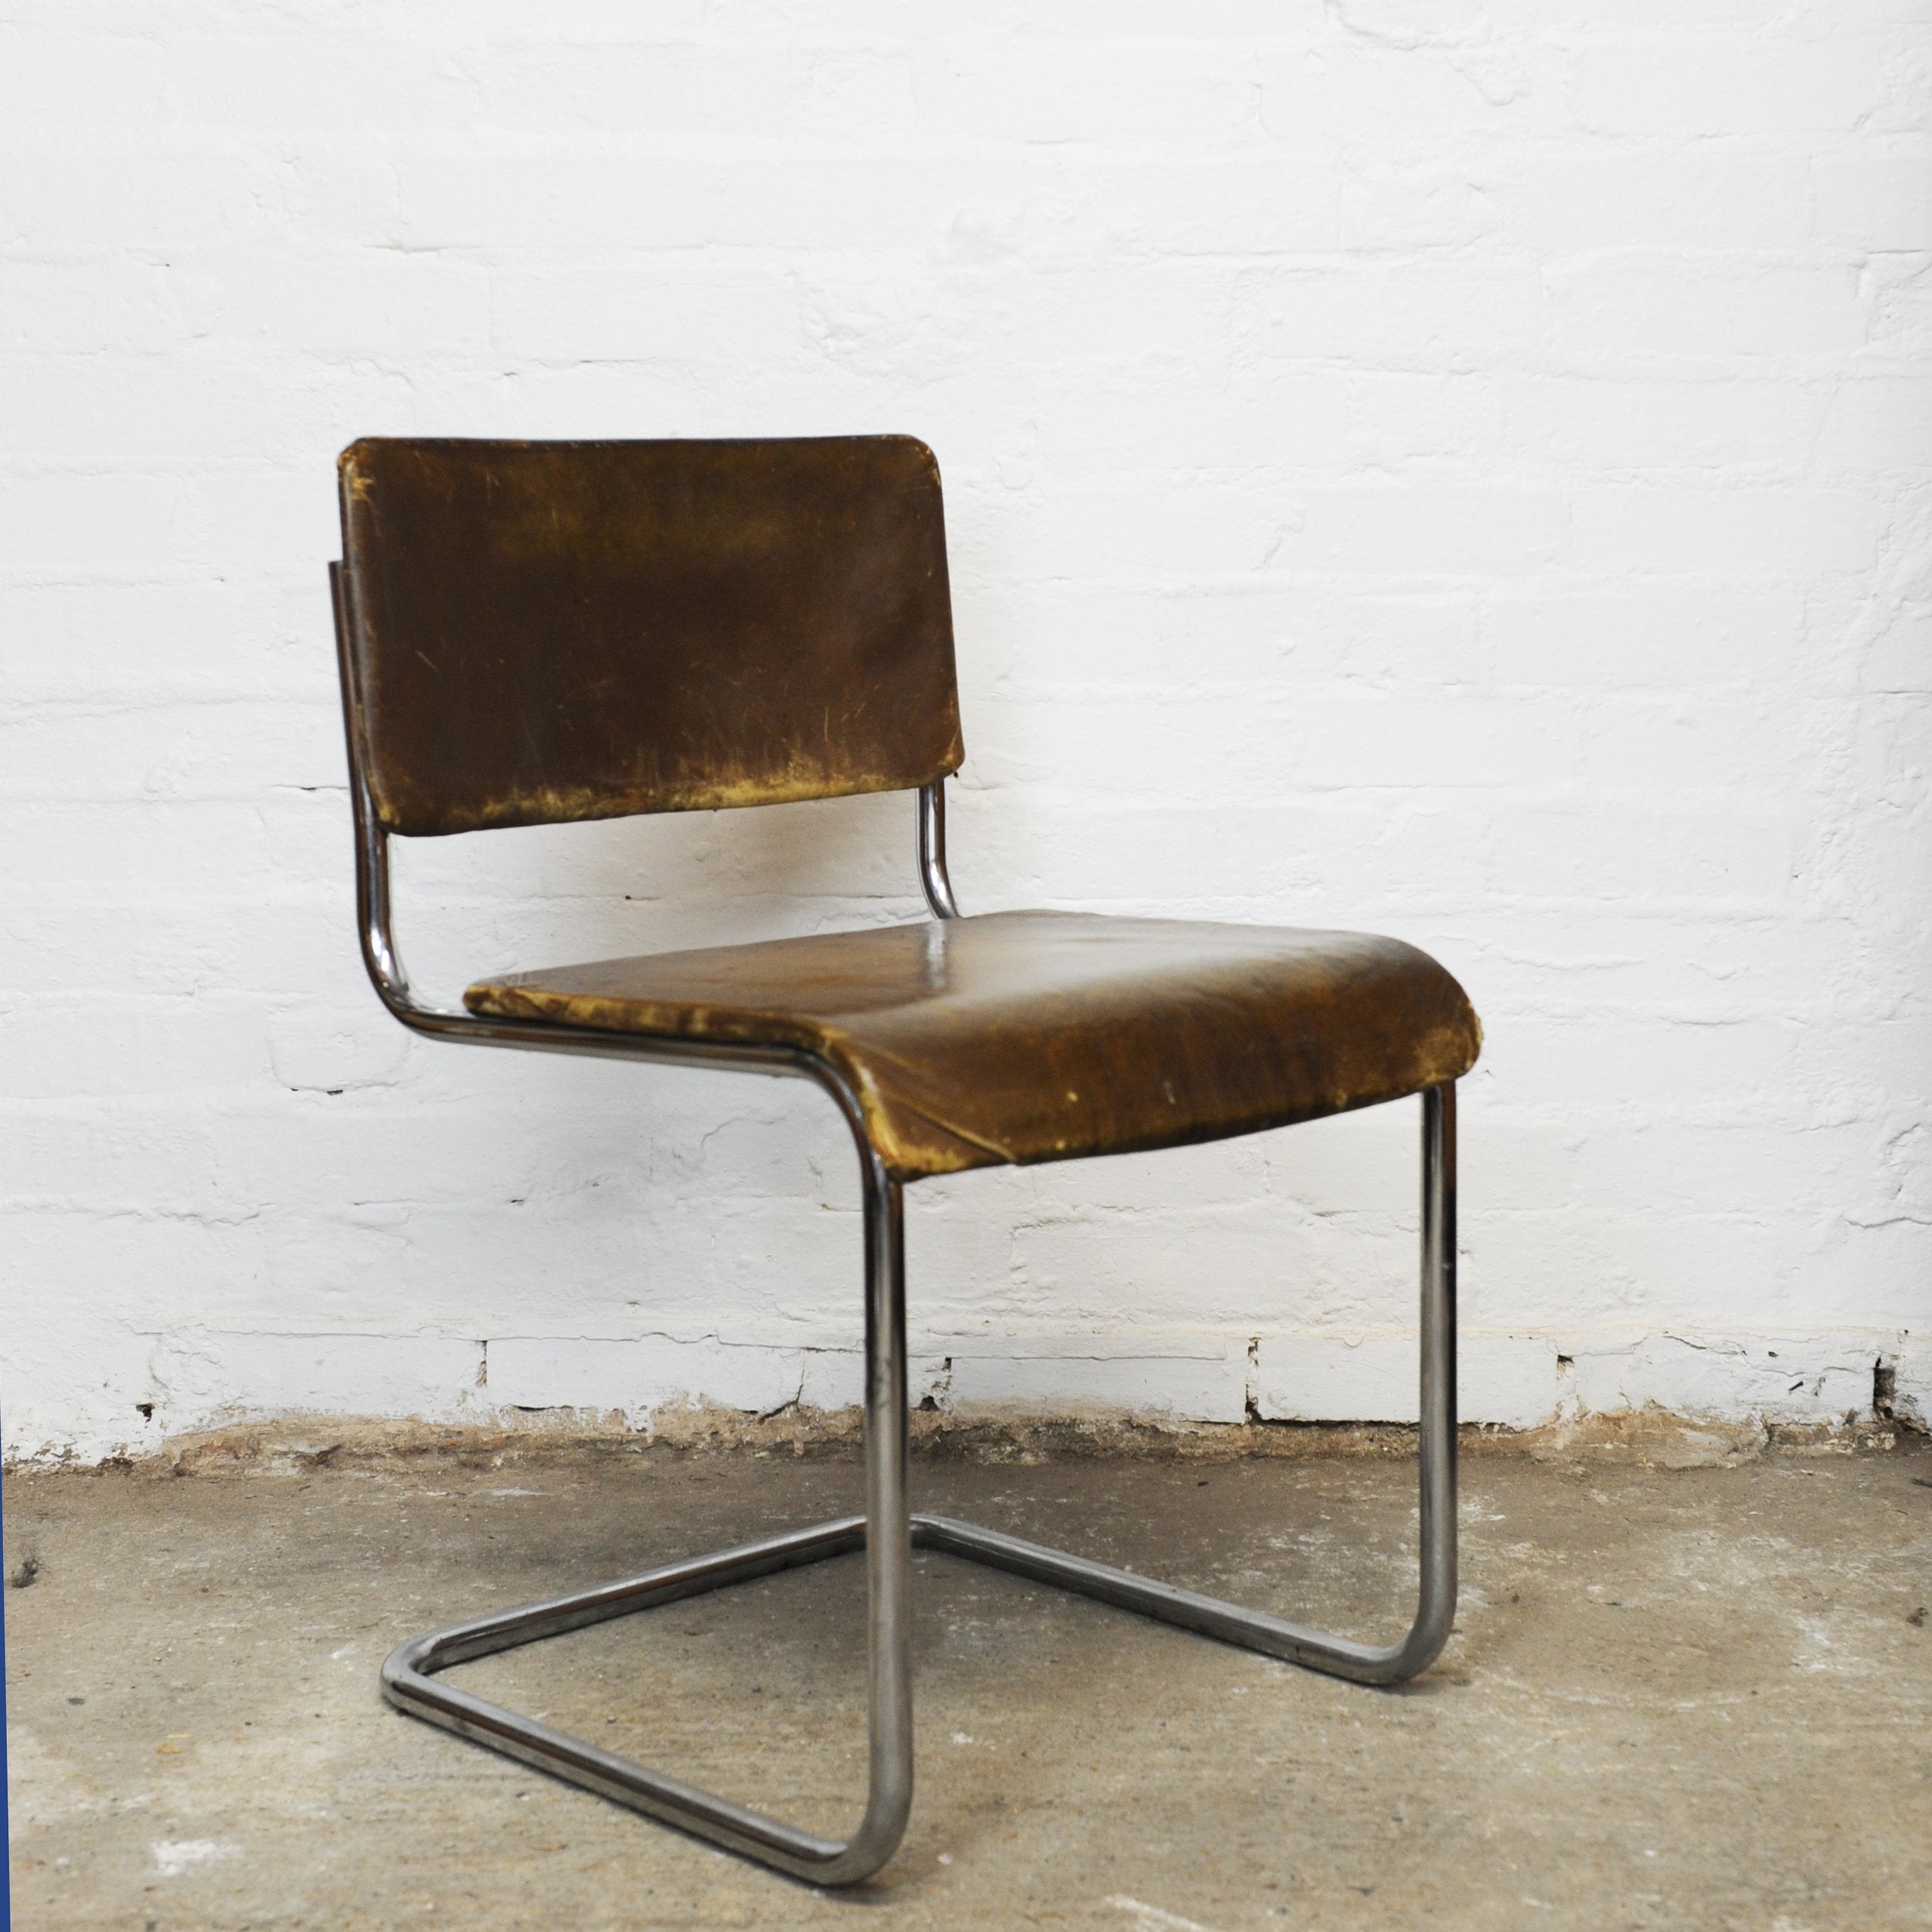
top-left (464, 912), bottom-right (1482, 1181)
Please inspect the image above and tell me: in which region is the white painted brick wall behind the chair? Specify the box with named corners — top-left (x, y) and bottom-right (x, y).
top-left (0, 0), bottom-right (1932, 1455)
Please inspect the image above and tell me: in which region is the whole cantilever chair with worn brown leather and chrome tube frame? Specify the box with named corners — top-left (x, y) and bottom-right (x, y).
top-left (331, 437), bottom-right (1480, 1886)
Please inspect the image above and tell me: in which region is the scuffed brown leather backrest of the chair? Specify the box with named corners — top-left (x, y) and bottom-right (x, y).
top-left (340, 437), bottom-right (962, 833)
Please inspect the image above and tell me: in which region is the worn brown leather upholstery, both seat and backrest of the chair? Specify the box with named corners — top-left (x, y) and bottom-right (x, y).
top-left (340, 437), bottom-right (1480, 1181)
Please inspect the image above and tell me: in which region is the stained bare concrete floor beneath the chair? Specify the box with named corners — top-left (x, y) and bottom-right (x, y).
top-left (6, 1432), bottom-right (1932, 1932)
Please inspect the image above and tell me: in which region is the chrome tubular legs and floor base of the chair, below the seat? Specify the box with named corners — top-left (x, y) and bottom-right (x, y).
top-left (383, 1084), bottom-right (1457, 1886)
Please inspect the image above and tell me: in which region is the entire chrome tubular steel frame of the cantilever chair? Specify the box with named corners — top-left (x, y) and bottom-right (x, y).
top-left (331, 566), bottom-right (1457, 1886)
